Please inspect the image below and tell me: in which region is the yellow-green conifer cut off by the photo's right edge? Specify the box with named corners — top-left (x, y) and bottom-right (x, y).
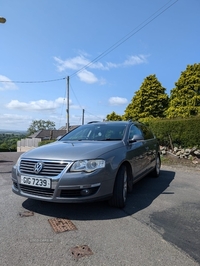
top-left (166, 64), bottom-right (200, 118)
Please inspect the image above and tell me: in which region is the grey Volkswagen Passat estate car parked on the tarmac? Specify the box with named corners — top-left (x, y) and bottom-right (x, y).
top-left (12, 121), bottom-right (161, 208)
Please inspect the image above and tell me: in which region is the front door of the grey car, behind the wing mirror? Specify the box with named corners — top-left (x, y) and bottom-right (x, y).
top-left (127, 125), bottom-right (146, 179)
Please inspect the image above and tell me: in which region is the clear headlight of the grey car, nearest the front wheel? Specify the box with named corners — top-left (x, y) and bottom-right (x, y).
top-left (70, 160), bottom-right (106, 172)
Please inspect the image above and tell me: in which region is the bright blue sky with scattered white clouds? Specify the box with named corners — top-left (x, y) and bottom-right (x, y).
top-left (0, 0), bottom-right (200, 130)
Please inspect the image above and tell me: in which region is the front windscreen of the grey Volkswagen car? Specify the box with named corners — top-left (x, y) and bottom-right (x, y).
top-left (60, 124), bottom-right (126, 141)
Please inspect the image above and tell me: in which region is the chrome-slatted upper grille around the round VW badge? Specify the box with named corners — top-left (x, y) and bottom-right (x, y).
top-left (19, 160), bottom-right (68, 176)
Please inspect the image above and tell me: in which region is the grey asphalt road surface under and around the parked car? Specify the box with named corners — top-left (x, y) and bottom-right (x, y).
top-left (0, 153), bottom-right (200, 266)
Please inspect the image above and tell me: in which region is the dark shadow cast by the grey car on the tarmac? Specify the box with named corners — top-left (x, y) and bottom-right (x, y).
top-left (22, 170), bottom-right (175, 220)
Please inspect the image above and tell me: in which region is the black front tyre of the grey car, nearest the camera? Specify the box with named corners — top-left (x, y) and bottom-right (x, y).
top-left (109, 165), bottom-right (128, 208)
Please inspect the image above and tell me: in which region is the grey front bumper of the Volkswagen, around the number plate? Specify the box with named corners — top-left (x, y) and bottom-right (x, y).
top-left (12, 167), bottom-right (115, 203)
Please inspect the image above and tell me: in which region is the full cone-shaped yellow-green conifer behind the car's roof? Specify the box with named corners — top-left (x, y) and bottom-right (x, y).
top-left (123, 75), bottom-right (168, 120)
